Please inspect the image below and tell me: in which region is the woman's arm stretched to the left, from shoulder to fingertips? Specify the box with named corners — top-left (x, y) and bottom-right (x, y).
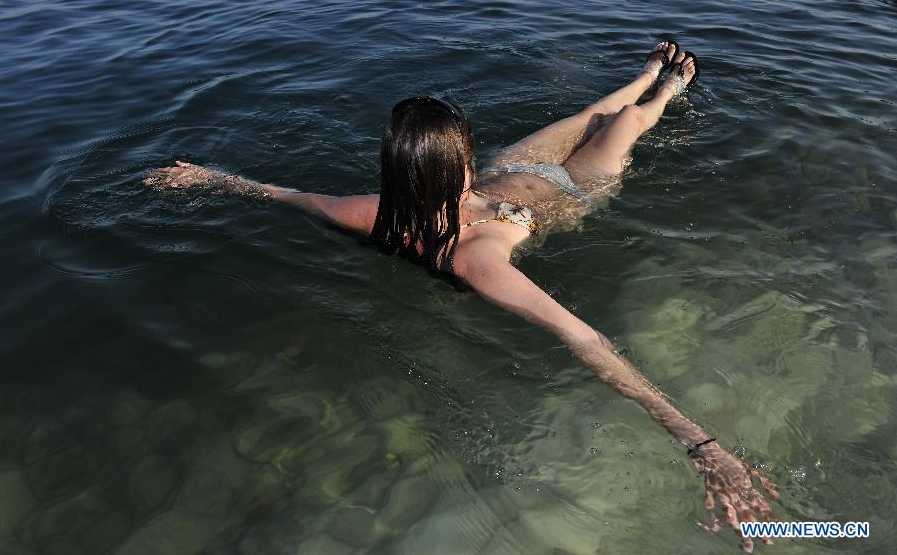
top-left (143, 161), bottom-right (380, 235)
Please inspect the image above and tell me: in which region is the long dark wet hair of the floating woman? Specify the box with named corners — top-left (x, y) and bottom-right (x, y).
top-left (371, 97), bottom-right (475, 271)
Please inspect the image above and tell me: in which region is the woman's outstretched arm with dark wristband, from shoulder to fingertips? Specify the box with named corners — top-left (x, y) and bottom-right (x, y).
top-left (454, 237), bottom-right (778, 551)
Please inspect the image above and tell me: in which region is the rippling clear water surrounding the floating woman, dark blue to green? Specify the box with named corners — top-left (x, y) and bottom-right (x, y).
top-left (0, 1), bottom-right (897, 554)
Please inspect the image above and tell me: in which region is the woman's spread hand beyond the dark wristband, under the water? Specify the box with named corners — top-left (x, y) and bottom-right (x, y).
top-left (690, 441), bottom-right (779, 553)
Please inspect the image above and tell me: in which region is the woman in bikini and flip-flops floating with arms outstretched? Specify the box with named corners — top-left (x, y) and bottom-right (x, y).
top-left (145, 41), bottom-right (778, 551)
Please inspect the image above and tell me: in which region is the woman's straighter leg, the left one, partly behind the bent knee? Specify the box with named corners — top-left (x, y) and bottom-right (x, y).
top-left (491, 42), bottom-right (674, 166)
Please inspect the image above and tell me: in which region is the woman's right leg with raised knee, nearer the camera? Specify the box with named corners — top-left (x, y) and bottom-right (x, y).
top-left (564, 53), bottom-right (695, 178)
